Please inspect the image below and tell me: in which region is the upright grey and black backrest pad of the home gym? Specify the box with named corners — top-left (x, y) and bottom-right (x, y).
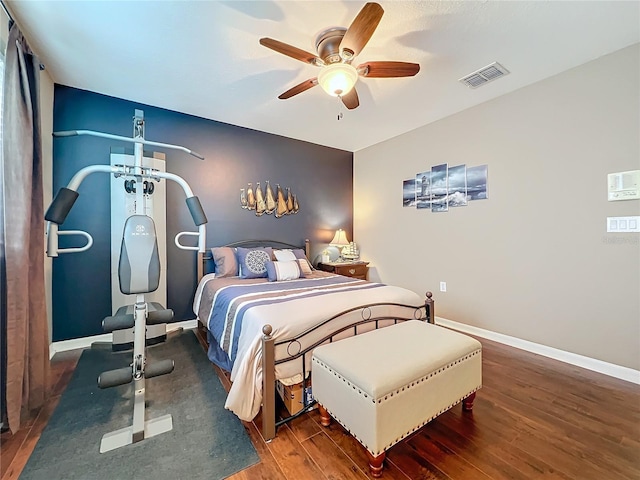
top-left (118, 215), bottom-right (160, 295)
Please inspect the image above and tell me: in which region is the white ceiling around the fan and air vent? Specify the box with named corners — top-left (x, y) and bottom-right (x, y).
top-left (4, 0), bottom-right (640, 152)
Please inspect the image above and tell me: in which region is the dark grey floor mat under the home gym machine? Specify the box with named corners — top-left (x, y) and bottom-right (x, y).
top-left (20, 331), bottom-right (260, 480)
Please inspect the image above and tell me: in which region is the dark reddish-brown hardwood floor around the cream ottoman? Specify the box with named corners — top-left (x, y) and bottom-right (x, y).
top-left (0, 330), bottom-right (640, 480)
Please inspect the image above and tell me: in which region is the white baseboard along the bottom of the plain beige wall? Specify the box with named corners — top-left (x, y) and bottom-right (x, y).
top-left (436, 316), bottom-right (640, 385)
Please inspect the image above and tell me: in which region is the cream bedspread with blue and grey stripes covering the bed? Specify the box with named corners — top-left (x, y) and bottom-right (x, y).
top-left (193, 271), bottom-right (424, 421)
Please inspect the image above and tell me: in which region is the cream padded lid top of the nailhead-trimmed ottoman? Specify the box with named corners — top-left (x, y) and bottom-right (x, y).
top-left (313, 320), bottom-right (482, 400)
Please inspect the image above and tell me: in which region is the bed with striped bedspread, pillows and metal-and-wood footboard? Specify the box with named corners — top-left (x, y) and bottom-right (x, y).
top-left (193, 240), bottom-right (435, 440)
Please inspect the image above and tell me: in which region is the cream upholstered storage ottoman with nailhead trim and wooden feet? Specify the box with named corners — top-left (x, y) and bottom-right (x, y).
top-left (311, 320), bottom-right (482, 477)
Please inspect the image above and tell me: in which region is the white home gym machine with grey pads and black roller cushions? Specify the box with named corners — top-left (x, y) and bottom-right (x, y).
top-left (45, 110), bottom-right (207, 453)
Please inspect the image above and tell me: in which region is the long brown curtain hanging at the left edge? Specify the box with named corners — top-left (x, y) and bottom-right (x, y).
top-left (0, 20), bottom-right (50, 433)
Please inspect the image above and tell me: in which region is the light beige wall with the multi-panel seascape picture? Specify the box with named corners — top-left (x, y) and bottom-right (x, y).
top-left (354, 44), bottom-right (640, 370)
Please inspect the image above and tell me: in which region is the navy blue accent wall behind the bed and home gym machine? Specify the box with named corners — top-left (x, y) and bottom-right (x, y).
top-left (53, 85), bottom-right (353, 341)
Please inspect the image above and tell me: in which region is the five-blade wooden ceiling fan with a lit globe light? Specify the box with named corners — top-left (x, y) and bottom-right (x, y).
top-left (260, 2), bottom-right (420, 110)
